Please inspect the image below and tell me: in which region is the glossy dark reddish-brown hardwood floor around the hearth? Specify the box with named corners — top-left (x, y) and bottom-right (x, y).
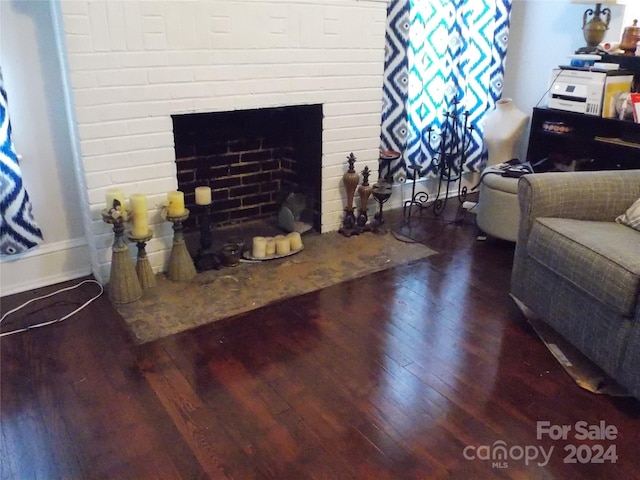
top-left (0, 204), bottom-right (640, 480)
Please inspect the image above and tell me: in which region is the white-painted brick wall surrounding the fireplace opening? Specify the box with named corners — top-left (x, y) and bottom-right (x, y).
top-left (61, 0), bottom-right (386, 281)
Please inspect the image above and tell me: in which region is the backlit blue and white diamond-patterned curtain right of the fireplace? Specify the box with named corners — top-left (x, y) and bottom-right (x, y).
top-left (381, 0), bottom-right (512, 178)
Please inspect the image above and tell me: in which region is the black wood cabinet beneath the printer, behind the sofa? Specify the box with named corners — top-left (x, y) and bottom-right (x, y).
top-left (527, 108), bottom-right (640, 170)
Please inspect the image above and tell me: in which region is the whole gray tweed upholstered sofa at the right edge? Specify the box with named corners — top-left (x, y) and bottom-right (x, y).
top-left (511, 170), bottom-right (640, 398)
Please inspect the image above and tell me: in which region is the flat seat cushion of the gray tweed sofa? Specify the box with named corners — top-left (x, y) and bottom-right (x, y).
top-left (527, 218), bottom-right (640, 317)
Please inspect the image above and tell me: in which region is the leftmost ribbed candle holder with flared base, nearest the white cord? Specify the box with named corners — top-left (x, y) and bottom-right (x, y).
top-left (102, 208), bottom-right (142, 303)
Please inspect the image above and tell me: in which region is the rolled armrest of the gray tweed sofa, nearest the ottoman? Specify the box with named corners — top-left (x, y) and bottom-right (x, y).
top-left (518, 170), bottom-right (640, 242)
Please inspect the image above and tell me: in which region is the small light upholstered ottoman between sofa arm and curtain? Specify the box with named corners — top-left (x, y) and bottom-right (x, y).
top-left (476, 167), bottom-right (520, 242)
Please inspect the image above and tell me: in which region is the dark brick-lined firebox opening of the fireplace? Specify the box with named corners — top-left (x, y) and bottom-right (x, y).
top-left (172, 105), bottom-right (322, 232)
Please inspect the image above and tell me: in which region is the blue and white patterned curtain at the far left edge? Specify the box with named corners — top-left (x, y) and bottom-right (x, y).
top-left (0, 69), bottom-right (42, 255)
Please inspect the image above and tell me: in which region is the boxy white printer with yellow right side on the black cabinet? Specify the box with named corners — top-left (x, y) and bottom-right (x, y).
top-left (547, 68), bottom-right (633, 118)
